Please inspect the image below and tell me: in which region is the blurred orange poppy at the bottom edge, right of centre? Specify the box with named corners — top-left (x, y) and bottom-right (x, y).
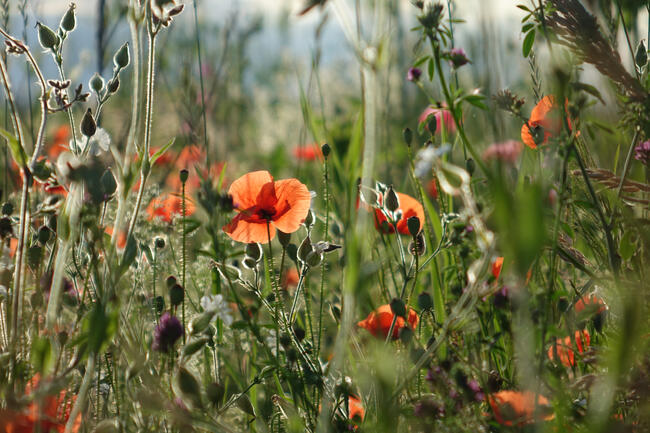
top-left (488, 391), bottom-right (554, 427)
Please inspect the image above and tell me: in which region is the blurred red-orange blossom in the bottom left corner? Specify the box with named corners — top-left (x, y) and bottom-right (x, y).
top-left (0, 373), bottom-right (81, 433)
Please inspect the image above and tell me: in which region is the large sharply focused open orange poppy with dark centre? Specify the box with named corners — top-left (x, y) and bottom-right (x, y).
top-left (223, 170), bottom-right (311, 244)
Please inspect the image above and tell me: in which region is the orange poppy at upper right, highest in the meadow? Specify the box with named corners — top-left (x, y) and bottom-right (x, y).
top-left (521, 95), bottom-right (571, 149)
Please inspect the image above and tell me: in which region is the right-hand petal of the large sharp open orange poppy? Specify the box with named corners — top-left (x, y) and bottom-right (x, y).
top-left (273, 179), bottom-right (311, 233)
